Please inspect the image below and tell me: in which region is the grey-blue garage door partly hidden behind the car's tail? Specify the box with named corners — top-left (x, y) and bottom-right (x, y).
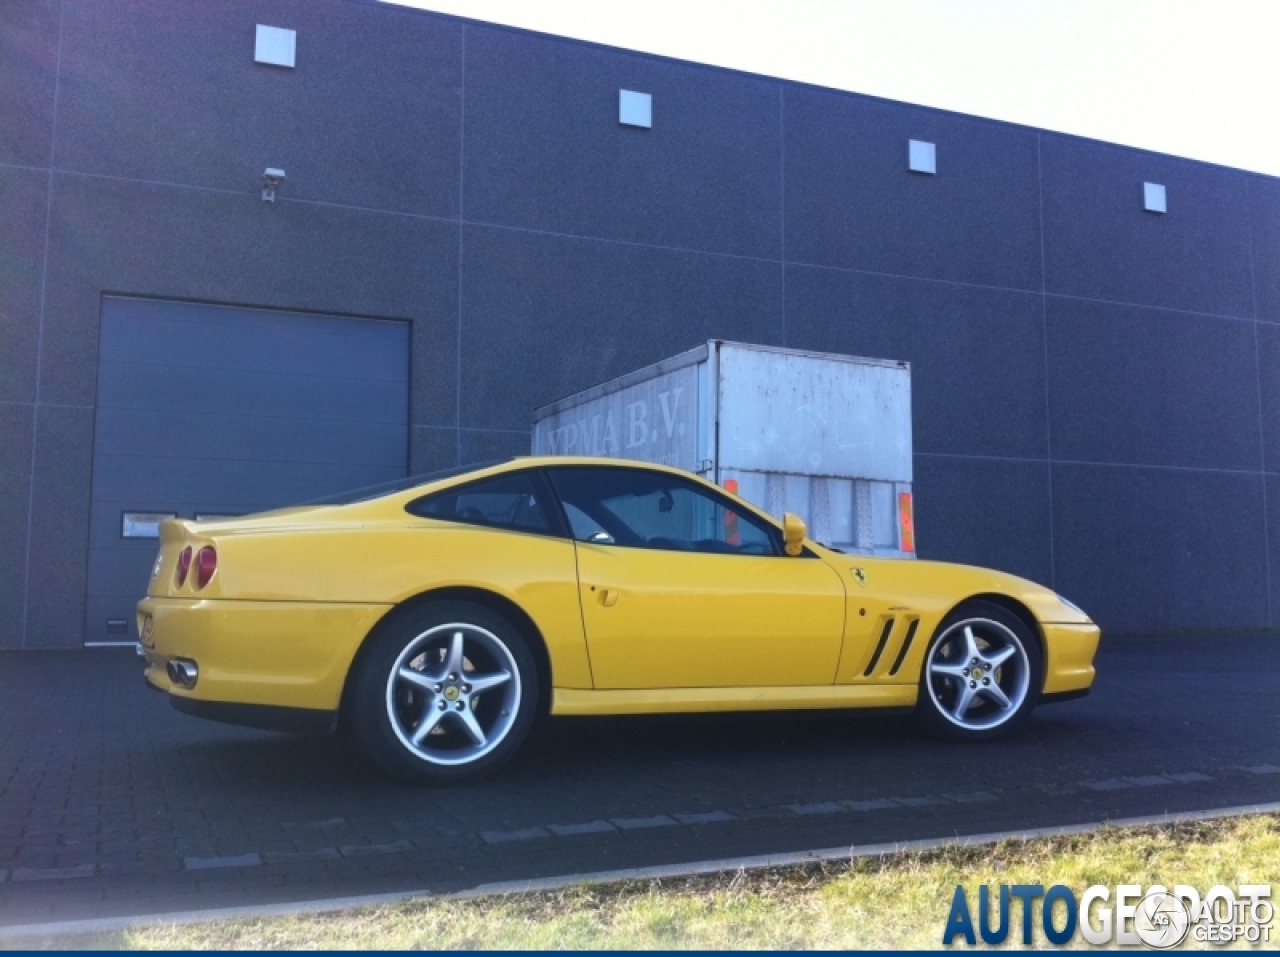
top-left (84, 297), bottom-right (410, 644)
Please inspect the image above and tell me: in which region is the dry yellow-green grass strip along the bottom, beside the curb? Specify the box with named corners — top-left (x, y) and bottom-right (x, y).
top-left (30, 815), bottom-right (1280, 949)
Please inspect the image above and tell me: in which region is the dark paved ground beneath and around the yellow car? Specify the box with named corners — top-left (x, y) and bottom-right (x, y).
top-left (0, 635), bottom-right (1280, 928)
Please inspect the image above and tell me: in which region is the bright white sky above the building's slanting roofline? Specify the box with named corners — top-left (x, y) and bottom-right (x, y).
top-left (397, 0), bottom-right (1280, 175)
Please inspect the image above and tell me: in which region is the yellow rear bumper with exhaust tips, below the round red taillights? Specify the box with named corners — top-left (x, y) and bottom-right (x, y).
top-left (138, 597), bottom-right (389, 727)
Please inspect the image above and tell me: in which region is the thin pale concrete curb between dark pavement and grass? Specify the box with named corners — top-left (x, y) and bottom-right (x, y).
top-left (0, 801), bottom-right (1280, 943)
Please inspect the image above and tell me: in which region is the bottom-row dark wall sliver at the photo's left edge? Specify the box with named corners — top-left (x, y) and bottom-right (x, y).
top-left (0, 403), bottom-right (35, 649)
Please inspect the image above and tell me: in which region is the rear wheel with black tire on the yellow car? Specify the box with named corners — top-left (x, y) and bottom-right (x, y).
top-left (347, 601), bottom-right (539, 784)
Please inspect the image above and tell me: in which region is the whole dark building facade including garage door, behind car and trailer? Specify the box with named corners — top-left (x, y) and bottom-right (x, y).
top-left (0, 0), bottom-right (1280, 649)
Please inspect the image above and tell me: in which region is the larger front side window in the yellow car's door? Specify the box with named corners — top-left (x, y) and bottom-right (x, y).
top-left (547, 466), bottom-right (778, 555)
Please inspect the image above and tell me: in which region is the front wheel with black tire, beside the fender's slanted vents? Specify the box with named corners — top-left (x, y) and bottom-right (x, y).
top-left (915, 600), bottom-right (1044, 741)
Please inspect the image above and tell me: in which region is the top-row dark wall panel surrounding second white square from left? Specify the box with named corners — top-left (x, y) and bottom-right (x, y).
top-left (465, 27), bottom-right (781, 257)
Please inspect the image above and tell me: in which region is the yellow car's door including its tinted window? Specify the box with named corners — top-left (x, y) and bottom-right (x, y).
top-left (547, 466), bottom-right (845, 688)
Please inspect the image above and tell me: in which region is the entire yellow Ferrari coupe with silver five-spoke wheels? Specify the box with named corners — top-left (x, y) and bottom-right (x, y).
top-left (138, 457), bottom-right (1100, 782)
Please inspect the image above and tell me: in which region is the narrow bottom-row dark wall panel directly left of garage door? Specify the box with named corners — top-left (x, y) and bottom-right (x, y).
top-left (26, 406), bottom-right (93, 649)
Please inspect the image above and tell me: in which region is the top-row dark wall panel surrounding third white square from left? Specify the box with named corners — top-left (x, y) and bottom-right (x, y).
top-left (785, 86), bottom-right (1041, 289)
